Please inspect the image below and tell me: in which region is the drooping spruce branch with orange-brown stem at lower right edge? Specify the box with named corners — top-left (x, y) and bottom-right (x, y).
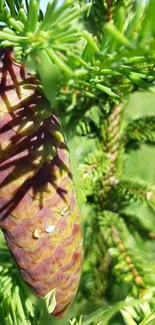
top-left (99, 211), bottom-right (154, 298)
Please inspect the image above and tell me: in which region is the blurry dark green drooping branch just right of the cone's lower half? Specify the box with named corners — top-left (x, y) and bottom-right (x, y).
top-left (79, 206), bottom-right (110, 306)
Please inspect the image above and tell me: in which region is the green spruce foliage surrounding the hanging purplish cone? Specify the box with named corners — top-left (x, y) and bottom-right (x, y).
top-left (0, 0), bottom-right (155, 325)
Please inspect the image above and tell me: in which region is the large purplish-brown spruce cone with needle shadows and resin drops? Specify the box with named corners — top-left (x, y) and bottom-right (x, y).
top-left (0, 48), bottom-right (82, 317)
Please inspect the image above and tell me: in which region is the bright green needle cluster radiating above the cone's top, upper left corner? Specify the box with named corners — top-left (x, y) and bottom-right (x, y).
top-left (0, 0), bottom-right (90, 79)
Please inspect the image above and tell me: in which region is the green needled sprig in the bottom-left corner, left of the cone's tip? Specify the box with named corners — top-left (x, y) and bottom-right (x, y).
top-left (0, 240), bottom-right (34, 325)
